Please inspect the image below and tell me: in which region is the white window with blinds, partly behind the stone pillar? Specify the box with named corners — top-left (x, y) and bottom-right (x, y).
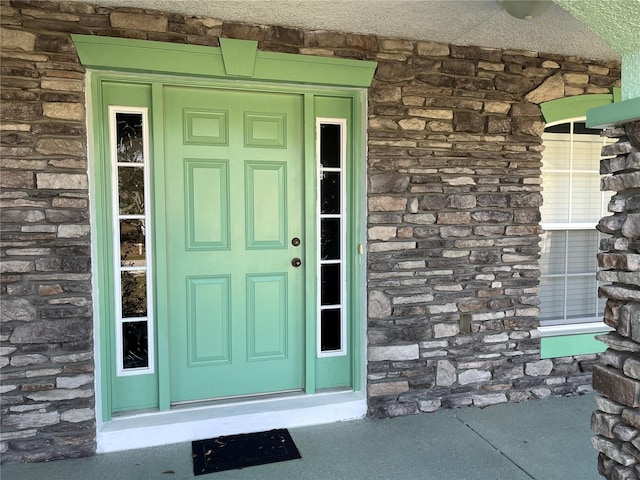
top-left (540, 118), bottom-right (610, 326)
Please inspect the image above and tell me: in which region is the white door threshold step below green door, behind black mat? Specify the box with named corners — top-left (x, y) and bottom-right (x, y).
top-left (96, 391), bottom-right (367, 453)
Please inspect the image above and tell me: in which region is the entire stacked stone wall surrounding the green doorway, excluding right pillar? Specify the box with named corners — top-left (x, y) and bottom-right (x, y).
top-left (0, 0), bottom-right (620, 461)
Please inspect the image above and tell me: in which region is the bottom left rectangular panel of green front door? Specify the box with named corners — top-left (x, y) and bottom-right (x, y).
top-left (187, 275), bottom-right (232, 367)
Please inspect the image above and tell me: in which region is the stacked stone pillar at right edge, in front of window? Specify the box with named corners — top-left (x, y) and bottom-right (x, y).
top-left (591, 122), bottom-right (640, 480)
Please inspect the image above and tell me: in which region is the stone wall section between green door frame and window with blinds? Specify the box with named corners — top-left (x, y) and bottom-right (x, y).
top-left (368, 44), bottom-right (619, 417)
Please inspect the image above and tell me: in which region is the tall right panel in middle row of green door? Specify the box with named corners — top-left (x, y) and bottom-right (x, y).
top-left (245, 161), bottom-right (287, 250)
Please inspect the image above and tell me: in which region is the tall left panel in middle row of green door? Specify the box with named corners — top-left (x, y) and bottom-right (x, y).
top-left (184, 158), bottom-right (230, 250)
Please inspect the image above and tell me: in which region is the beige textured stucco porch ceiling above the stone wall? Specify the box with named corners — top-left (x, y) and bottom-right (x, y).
top-left (74, 0), bottom-right (624, 59)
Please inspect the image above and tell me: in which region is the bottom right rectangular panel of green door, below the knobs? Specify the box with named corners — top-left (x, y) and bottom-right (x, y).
top-left (247, 273), bottom-right (289, 361)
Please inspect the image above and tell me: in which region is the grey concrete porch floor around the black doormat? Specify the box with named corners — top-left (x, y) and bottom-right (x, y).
top-left (0, 394), bottom-right (602, 480)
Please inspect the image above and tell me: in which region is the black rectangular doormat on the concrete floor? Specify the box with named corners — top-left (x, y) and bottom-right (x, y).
top-left (191, 428), bottom-right (302, 476)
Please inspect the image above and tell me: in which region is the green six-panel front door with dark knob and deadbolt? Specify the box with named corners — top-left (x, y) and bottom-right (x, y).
top-left (164, 86), bottom-right (306, 403)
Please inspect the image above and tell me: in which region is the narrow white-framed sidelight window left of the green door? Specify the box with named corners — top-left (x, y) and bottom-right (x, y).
top-left (109, 107), bottom-right (154, 376)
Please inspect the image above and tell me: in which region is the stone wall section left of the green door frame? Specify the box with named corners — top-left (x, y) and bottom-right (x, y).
top-left (0, 2), bottom-right (95, 462)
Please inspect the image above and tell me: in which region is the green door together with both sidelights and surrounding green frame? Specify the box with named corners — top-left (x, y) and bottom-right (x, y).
top-left (95, 77), bottom-right (361, 420)
